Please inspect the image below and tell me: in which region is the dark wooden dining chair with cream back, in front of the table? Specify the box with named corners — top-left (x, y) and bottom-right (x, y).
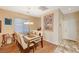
top-left (13, 33), bottom-right (34, 52)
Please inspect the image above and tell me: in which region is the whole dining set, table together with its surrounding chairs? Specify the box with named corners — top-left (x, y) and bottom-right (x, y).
top-left (0, 32), bottom-right (43, 53)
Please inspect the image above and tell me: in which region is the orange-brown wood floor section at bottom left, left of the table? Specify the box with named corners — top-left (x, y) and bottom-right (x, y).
top-left (0, 43), bottom-right (20, 53)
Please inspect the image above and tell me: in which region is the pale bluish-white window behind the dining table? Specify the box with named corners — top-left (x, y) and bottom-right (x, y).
top-left (14, 18), bottom-right (30, 33)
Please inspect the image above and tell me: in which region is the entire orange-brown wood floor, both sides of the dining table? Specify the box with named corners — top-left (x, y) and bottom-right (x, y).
top-left (0, 41), bottom-right (57, 53)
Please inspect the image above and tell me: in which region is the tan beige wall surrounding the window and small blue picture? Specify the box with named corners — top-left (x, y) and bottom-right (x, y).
top-left (0, 9), bottom-right (40, 33)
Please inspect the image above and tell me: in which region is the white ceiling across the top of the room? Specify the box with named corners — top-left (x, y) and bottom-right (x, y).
top-left (0, 6), bottom-right (79, 17)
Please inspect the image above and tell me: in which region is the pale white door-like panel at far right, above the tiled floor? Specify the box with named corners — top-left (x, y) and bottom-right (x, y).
top-left (62, 15), bottom-right (77, 40)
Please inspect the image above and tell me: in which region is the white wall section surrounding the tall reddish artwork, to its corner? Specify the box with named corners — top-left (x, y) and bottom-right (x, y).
top-left (41, 9), bottom-right (62, 45)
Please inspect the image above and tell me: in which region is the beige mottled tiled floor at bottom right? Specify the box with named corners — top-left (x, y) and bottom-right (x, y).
top-left (54, 39), bottom-right (79, 53)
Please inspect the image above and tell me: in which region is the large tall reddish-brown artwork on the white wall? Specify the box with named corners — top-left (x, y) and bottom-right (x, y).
top-left (44, 13), bottom-right (54, 31)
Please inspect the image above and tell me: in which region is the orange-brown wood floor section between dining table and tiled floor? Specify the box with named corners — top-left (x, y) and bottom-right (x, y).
top-left (35, 41), bottom-right (57, 53)
